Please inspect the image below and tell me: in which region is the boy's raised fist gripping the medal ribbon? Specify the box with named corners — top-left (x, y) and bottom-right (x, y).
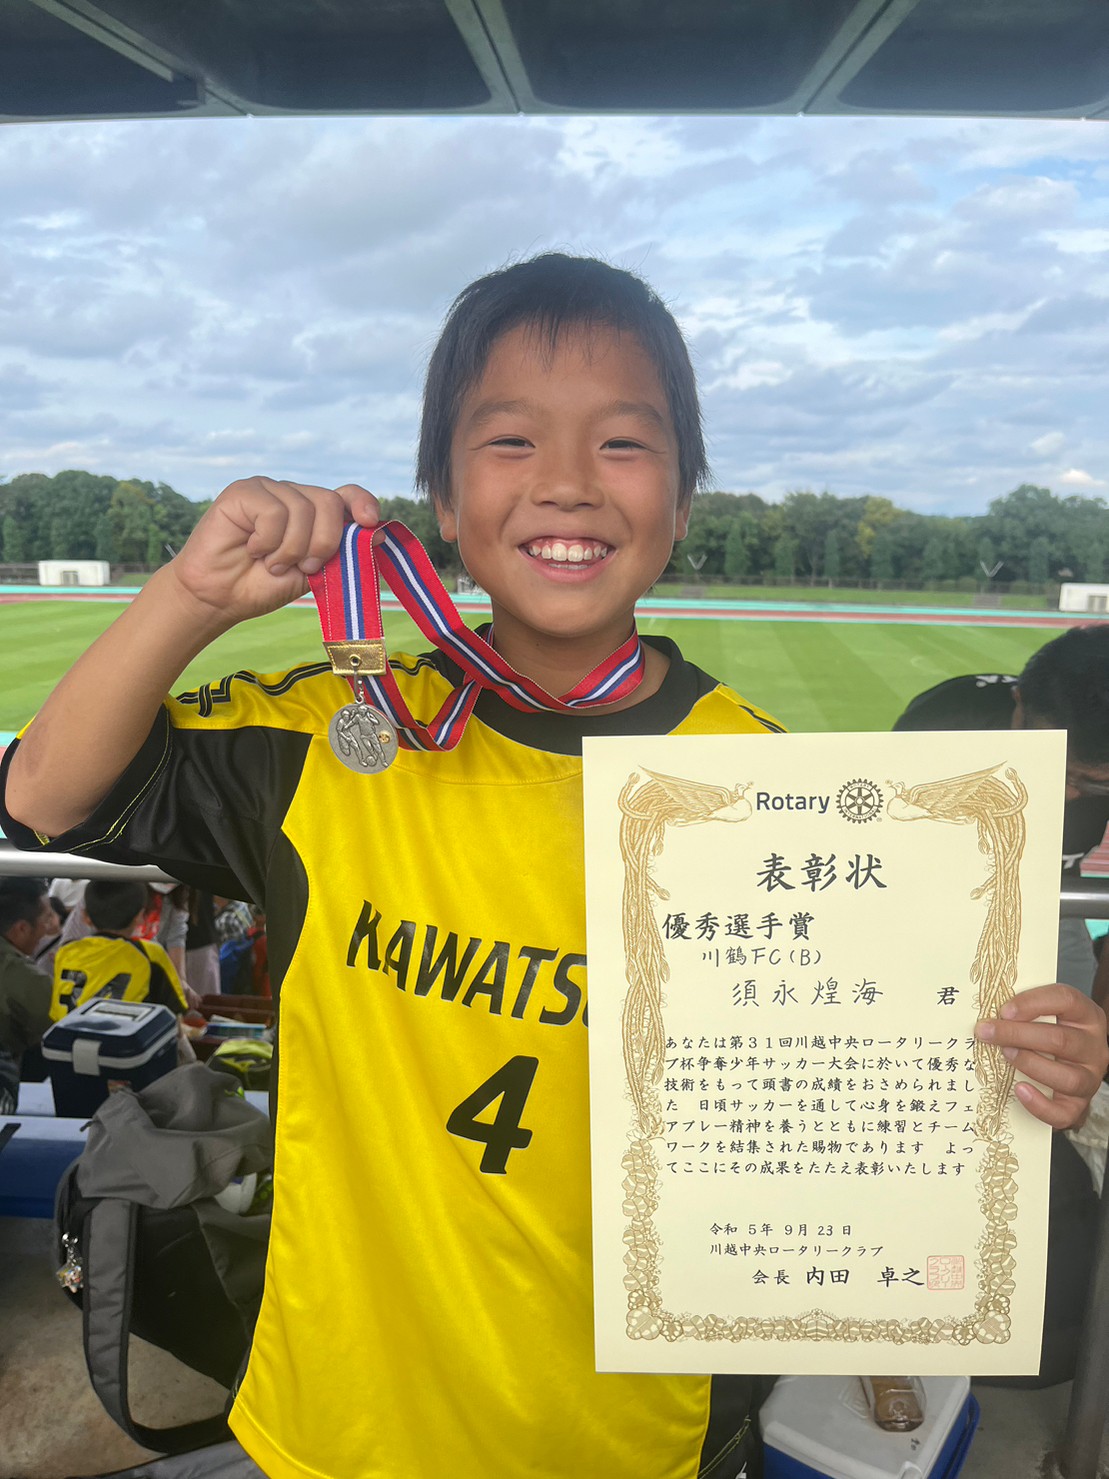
top-left (169, 478), bottom-right (380, 627)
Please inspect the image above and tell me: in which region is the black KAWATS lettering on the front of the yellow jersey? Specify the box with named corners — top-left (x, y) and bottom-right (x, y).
top-left (346, 899), bottom-right (586, 1026)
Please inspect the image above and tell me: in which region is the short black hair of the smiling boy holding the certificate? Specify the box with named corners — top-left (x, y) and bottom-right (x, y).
top-left (416, 251), bottom-right (708, 503)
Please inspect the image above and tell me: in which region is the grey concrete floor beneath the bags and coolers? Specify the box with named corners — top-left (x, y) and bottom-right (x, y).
top-left (0, 1217), bottom-right (1109, 1479)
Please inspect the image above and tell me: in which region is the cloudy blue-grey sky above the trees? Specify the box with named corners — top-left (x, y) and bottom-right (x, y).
top-left (0, 117), bottom-right (1109, 515)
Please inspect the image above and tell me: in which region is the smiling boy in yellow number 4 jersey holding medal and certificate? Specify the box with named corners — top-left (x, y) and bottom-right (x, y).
top-left (4, 254), bottom-right (1106, 1479)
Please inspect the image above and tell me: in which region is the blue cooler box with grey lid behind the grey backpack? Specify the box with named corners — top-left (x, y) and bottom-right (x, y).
top-left (43, 997), bottom-right (177, 1118)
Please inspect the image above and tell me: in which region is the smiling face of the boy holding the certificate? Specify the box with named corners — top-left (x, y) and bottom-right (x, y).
top-left (439, 327), bottom-right (689, 671)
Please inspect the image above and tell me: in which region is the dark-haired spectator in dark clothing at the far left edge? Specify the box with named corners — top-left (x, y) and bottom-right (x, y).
top-left (0, 879), bottom-right (58, 1114)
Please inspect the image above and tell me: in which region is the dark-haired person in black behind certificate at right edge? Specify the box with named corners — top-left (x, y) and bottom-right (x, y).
top-left (893, 623), bottom-right (1109, 1007)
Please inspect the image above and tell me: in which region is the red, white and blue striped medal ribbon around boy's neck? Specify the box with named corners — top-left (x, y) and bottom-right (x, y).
top-left (308, 519), bottom-right (643, 750)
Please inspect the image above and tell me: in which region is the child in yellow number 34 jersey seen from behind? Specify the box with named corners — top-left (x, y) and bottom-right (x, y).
top-left (50, 879), bottom-right (188, 1022)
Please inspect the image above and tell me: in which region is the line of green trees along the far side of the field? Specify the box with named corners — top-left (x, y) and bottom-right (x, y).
top-left (0, 470), bottom-right (1109, 586)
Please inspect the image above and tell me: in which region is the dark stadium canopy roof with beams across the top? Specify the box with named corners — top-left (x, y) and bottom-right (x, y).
top-left (0, 0), bottom-right (1109, 123)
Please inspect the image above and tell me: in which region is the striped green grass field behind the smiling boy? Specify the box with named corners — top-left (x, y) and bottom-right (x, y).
top-left (0, 600), bottom-right (1054, 732)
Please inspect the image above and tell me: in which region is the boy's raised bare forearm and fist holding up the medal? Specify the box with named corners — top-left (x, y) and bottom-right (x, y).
top-left (6, 478), bottom-right (379, 837)
